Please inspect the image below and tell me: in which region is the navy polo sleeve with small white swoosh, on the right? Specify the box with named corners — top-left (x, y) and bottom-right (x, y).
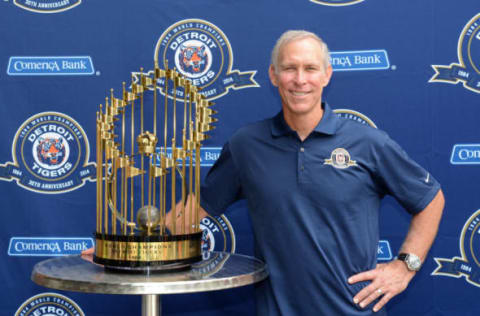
top-left (374, 136), bottom-right (440, 214)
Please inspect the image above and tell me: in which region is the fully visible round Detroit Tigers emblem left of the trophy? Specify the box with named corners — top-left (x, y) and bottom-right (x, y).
top-left (0, 112), bottom-right (95, 193)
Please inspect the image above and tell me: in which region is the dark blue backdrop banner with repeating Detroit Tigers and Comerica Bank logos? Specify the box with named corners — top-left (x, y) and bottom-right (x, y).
top-left (0, 0), bottom-right (480, 316)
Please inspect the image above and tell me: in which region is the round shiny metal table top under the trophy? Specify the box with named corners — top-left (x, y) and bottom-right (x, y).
top-left (31, 252), bottom-right (268, 294)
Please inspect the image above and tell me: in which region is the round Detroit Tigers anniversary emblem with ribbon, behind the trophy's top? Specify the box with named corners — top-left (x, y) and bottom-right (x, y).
top-left (154, 19), bottom-right (258, 100)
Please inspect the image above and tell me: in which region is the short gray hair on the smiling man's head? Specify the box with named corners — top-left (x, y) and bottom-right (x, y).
top-left (270, 30), bottom-right (330, 72)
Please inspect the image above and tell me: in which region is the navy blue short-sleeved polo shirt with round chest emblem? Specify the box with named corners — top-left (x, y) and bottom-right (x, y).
top-left (201, 105), bottom-right (440, 316)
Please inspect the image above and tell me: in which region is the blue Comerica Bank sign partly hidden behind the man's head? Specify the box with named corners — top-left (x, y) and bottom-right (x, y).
top-left (330, 49), bottom-right (390, 71)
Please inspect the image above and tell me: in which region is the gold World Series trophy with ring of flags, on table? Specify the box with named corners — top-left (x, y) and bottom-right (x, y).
top-left (93, 60), bottom-right (217, 273)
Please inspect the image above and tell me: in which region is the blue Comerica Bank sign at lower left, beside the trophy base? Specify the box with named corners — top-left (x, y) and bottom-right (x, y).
top-left (8, 237), bottom-right (93, 257)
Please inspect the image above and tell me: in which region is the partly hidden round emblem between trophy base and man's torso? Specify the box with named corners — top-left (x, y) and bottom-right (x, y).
top-left (200, 215), bottom-right (235, 260)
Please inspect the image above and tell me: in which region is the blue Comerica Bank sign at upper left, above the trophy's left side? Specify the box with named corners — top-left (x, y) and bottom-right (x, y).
top-left (7, 56), bottom-right (95, 76)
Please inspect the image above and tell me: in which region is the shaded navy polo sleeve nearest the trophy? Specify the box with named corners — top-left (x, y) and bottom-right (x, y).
top-left (200, 143), bottom-right (243, 216)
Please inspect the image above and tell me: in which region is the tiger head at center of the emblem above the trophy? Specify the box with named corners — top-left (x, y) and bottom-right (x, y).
top-left (177, 44), bottom-right (209, 76)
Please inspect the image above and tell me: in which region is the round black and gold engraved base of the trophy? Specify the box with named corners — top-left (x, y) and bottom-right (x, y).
top-left (93, 231), bottom-right (202, 274)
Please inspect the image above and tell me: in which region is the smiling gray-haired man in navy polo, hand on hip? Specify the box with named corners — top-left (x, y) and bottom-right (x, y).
top-left (181, 31), bottom-right (444, 316)
